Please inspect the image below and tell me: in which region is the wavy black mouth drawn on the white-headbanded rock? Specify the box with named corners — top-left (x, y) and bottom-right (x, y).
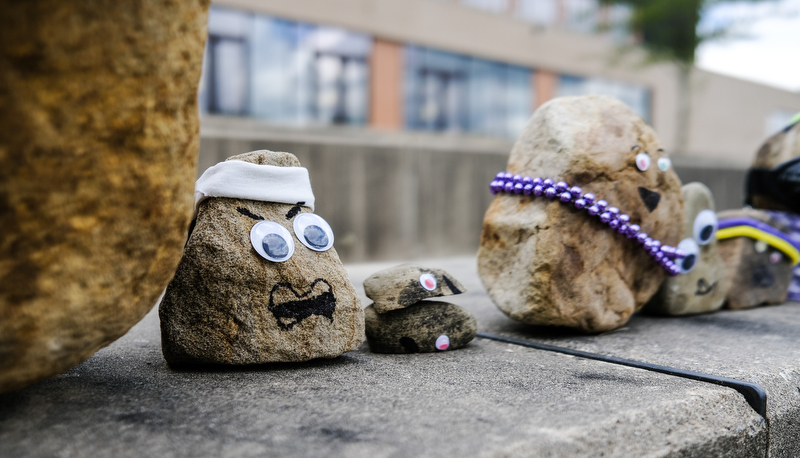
top-left (268, 278), bottom-right (336, 331)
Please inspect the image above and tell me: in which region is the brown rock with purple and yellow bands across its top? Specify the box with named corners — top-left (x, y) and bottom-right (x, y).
top-left (717, 208), bottom-right (800, 309)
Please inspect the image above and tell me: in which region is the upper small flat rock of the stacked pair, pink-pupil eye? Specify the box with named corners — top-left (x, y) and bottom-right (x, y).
top-left (364, 264), bottom-right (467, 313)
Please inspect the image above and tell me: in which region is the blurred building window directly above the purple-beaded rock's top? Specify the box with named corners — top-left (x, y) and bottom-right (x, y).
top-left (556, 75), bottom-right (650, 123)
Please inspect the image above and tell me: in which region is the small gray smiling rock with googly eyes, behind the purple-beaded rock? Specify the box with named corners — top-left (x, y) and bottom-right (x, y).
top-left (645, 183), bottom-right (729, 315)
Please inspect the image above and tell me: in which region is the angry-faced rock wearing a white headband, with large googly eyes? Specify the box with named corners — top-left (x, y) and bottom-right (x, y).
top-left (159, 151), bottom-right (364, 365)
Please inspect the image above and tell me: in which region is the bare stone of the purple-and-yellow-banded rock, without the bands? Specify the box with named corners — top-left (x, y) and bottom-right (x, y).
top-left (717, 208), bottom-right (792, 309)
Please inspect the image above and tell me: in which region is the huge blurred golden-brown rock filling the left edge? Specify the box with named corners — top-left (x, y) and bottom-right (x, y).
top-left (0, 0), bottom-right (209, 391)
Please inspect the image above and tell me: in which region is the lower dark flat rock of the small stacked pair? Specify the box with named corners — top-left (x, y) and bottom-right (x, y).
top-left (364, 301), bottom-right (478, 353)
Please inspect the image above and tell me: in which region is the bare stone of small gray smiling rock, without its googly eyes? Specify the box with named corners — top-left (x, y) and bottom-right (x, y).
top-left (645, 183), bottom-right (730, 315)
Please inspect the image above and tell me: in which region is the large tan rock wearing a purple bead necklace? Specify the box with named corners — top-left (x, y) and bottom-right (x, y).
top-left (478, 96), bottom-right (684, 332)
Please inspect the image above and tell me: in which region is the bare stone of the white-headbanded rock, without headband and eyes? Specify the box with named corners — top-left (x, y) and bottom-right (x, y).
top-left (159, 151), bottom-right (364, 365)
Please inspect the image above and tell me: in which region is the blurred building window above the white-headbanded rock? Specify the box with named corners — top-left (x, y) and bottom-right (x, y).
top-left (199, 7), bottom-right (372, 125)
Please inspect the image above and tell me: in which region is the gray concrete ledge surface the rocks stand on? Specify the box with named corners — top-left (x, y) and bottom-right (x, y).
top-left (0, 257), bottom-right (800, 457)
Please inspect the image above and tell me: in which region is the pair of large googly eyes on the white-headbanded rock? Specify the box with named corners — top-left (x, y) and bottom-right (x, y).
top-left (250, 213), bottom-right (333, 262)
